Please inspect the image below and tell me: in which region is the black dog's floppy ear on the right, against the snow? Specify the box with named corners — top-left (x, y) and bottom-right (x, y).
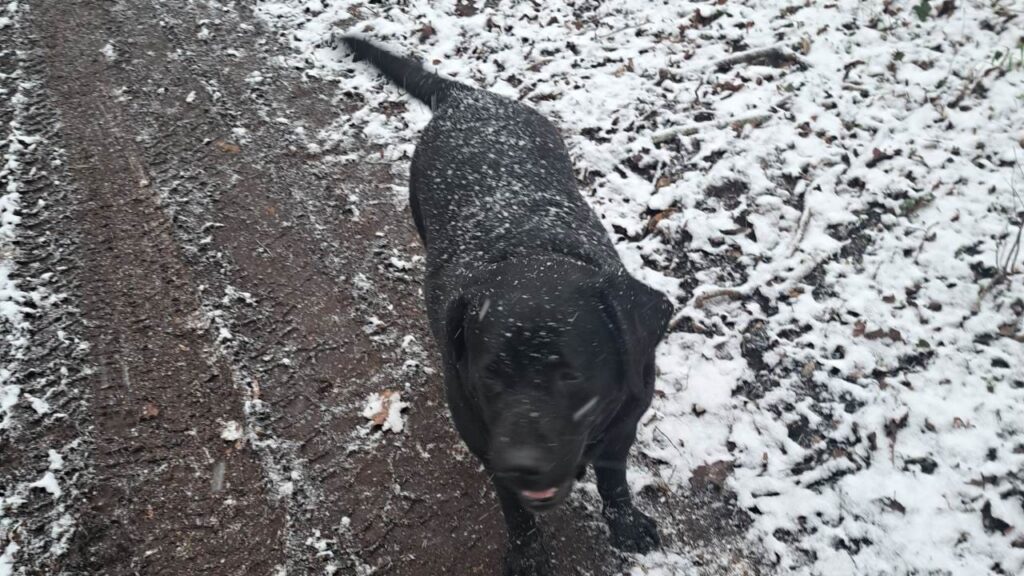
top-left (600, 271), bottom-right (672, 397)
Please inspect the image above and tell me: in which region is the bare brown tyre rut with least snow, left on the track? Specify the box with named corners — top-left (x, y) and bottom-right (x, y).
top-left (28, 3), bottom-right (283, 574)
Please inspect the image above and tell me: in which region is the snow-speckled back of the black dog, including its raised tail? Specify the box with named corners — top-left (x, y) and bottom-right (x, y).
top-left (345, 38), bottom-right (621, 269)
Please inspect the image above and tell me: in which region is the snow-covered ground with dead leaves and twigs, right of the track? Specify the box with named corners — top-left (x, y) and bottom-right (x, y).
top-left (257, 0), bottom-right (1024, 575)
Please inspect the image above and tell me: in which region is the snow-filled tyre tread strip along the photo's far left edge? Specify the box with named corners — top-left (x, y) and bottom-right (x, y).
top-left (0, 8), bottom-right (89, 574)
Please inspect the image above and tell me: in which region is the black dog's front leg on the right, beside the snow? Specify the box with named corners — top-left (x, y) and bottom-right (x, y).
top-left (594, 427), bottom-right (662, 553)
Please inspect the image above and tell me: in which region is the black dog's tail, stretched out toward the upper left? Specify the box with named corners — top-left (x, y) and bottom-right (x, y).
top-left (341, 36), bottom-right (468, 109)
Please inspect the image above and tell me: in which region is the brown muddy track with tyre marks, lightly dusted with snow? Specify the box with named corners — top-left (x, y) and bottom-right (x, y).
top-left (0, 0), bottom-right (756, 576)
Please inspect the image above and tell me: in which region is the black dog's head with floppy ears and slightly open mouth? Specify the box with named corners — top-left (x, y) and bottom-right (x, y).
top-left (446, 265), bottom-right (672, 510)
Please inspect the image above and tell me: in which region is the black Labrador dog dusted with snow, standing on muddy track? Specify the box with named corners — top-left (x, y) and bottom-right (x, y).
top-left (343, 37), bottom-right (672, 575)
